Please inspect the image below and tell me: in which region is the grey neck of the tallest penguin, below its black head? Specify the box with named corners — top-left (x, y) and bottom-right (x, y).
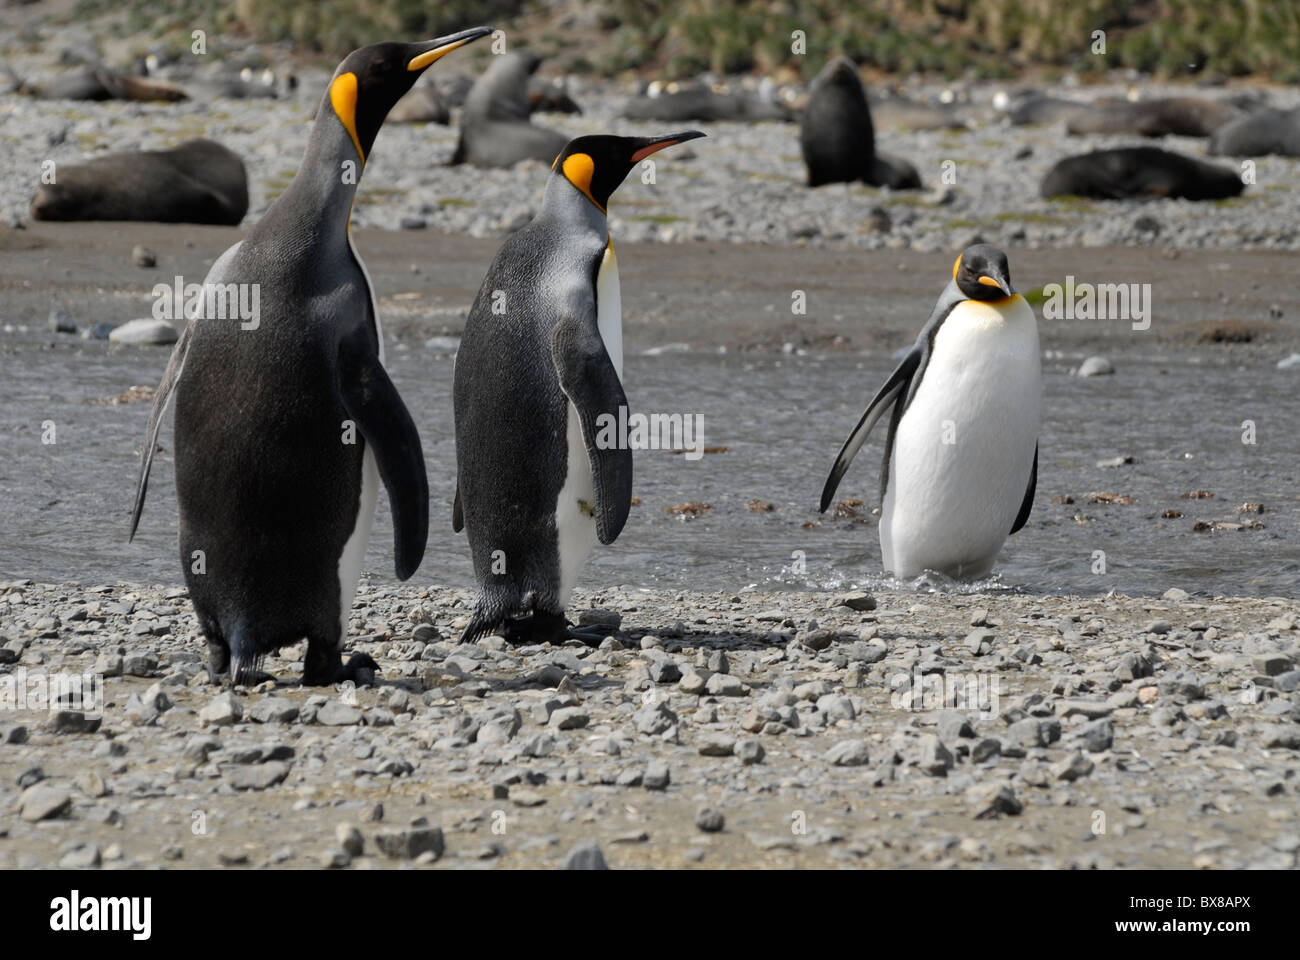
top-left (283, 104), bottom-right (365, 239)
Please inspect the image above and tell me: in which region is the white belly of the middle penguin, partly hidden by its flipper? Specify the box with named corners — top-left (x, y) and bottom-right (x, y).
top-left (555, 245), bottom-right (623, 606)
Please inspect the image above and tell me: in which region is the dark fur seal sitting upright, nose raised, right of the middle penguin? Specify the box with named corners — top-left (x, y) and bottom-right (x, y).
top-left (800, 57), bottom-right (920, 190)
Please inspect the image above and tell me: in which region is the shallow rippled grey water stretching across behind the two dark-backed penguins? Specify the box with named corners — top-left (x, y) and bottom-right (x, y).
top-left (0, 333), bottom-right (1300, 597)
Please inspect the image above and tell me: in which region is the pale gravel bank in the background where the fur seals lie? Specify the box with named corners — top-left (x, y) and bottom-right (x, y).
top-left (0, 68), bottom-right (1300, 251)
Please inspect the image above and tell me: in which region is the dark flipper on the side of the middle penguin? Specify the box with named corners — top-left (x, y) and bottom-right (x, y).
top-left (551, 308), bottom-right (632, 544)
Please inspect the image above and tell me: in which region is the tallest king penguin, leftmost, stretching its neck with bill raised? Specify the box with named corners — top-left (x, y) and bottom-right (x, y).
top-left (131, 27), bottom-right (491, 684)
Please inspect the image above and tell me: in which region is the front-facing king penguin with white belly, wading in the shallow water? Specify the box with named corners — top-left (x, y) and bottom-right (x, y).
top-left (822, 243), bottom-right (1043, 580)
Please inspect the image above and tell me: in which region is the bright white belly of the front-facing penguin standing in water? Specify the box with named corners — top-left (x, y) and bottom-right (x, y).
top-left (880, 295), bottom-right (1043, 579)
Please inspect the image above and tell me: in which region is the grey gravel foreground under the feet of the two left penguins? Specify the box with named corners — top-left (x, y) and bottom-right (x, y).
top-left (0, 579), bottom-right (1300, 869)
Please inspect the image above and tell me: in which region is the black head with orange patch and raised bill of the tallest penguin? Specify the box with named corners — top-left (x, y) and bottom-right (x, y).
top-left (329, 27), bottom-right (491, 161)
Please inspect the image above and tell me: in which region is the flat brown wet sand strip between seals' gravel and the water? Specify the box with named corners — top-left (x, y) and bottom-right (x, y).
top-left (0, 222), bottom-right (1300, 359)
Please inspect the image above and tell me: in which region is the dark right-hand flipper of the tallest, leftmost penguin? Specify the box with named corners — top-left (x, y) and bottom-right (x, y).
top-left (338, 328), bottom-right (429, 580)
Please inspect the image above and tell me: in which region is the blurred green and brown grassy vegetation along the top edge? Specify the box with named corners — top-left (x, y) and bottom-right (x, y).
top-left (63, 0), bottom-right (1300, 82)
